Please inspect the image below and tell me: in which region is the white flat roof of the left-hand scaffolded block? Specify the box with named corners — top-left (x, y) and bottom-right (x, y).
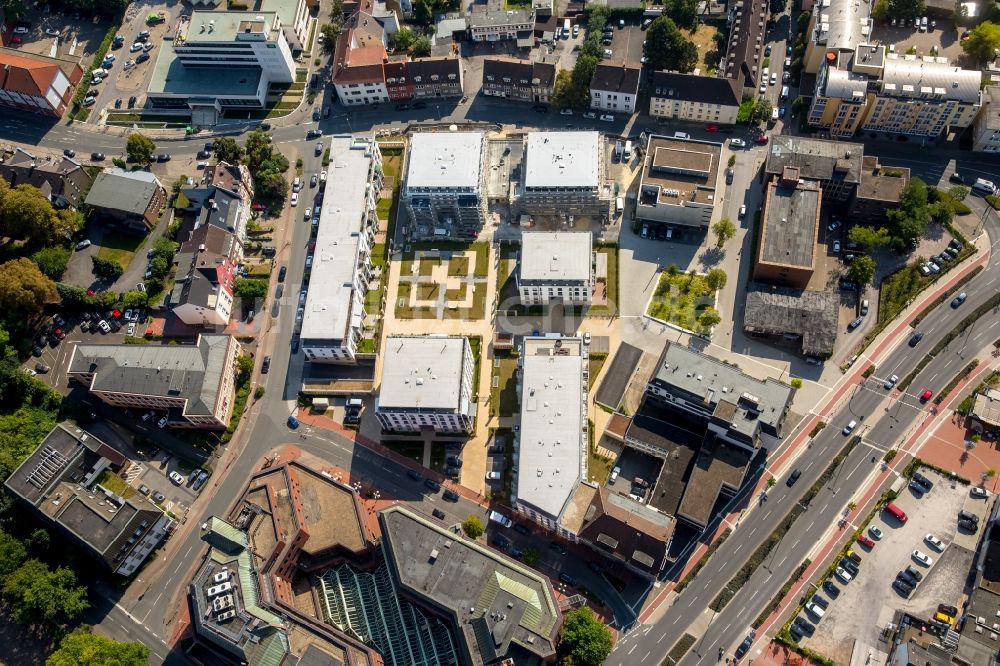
top-left (406, 132), bottom-right (486, 189)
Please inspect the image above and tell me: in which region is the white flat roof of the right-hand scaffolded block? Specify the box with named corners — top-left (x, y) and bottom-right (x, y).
top-left (524, 132), bottom-right (601, 188)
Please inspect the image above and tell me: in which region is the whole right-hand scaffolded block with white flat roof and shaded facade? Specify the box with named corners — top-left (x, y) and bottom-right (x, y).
top-left (517, 131), bottom-right (612, 219)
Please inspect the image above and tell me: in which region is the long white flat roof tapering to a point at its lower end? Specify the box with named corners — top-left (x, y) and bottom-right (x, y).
top-left (517, 337), bottom-right (588, 519)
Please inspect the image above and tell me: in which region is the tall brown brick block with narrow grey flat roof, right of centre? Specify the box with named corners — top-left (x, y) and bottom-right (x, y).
top-left (753, 167), bottom-right (822, 289)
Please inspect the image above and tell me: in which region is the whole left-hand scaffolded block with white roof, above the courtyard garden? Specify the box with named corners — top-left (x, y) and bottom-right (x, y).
top-left (400, 132), bottom-right (487, 238)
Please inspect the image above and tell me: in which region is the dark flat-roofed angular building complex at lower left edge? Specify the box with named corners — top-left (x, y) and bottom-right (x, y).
top-left (4, 422), bottom-right (173, 576)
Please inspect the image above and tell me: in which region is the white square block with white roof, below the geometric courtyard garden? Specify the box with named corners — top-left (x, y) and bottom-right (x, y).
top-left (375, 335), bottom-right (476, 432)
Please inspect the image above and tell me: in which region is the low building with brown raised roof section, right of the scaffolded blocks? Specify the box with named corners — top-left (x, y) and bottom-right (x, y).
top-left (635, 134), bottom-right (722, 230)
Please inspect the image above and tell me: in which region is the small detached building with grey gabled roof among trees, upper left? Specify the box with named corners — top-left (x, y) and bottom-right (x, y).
top-left (86, 167), bottom-right (167, 232)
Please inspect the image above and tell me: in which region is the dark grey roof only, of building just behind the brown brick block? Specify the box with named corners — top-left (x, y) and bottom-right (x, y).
top-left (767, 135), bottom-right (864, 183)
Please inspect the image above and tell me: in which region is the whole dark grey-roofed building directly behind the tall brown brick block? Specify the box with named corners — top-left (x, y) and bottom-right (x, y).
top-left (764, 135), bottom-right (864, 204)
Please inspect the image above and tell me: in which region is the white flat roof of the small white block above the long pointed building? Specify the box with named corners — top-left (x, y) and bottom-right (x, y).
top-left (521, 231), bottom-right (592, 281)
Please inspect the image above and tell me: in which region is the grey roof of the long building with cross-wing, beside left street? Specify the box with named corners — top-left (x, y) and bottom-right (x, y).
top-left (69, 335), bottom-right (232, 415)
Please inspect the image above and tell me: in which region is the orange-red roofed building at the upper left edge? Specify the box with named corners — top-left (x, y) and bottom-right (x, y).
top-left (0, 48), bottom-right (83, 118)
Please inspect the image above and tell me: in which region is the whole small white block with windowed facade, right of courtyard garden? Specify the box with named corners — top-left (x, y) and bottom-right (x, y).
top-left (516, 231), bottom-right (594, 305)
